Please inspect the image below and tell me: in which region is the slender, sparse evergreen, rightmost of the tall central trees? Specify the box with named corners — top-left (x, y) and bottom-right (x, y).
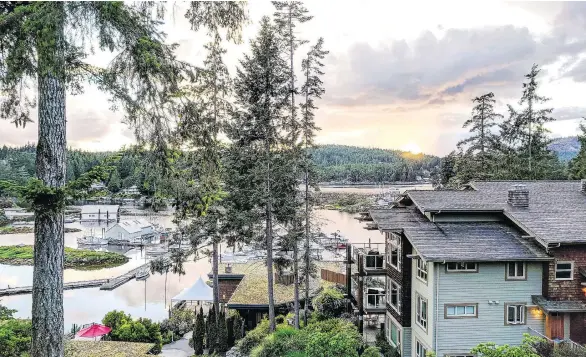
top-left (296, 38), bottom-right (328, 326)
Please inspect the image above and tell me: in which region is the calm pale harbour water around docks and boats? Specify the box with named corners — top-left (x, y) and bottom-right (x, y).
top-left (0, 186), bottom-right (424, 331)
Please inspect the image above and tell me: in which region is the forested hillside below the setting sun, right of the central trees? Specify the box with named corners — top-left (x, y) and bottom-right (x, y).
top-left (312, 145), bottom-right (440, 183)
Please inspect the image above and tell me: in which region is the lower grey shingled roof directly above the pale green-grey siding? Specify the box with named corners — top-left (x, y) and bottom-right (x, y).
top-left (371, 207), bottom-right (551, 262)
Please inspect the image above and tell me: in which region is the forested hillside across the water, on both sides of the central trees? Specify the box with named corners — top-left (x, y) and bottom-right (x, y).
top-left (0, 144), bottom-right (440, 188)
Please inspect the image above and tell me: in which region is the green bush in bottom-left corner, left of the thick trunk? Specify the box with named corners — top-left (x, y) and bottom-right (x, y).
top-left (0, 319), bottom-right (32, 357)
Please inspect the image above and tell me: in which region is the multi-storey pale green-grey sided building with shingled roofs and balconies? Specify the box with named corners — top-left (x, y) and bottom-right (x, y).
top-left (352, 181), bottom-right (586, 357)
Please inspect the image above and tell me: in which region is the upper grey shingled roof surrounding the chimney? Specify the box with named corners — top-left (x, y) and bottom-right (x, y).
top-left (407, 181), bottom-right (586, 244)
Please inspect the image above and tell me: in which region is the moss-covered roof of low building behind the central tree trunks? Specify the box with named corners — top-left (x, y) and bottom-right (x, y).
top-left (224, 260), bottom-right (341, 306)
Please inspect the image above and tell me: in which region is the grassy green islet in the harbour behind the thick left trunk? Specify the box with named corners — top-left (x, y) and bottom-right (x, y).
top-left (0, 245), bottom-right (128, 269)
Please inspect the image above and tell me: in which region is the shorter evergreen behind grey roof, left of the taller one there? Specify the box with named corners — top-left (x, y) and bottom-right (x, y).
top-left (458, 92), bottom-right (503, 179)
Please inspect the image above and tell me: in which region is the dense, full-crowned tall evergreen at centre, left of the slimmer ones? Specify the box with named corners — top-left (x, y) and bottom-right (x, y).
top-left (227, 17), bottom-right (296, 331)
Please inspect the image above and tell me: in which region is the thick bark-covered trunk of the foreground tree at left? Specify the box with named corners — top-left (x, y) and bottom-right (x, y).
top-left (31, 5), bottom-right (67, 357)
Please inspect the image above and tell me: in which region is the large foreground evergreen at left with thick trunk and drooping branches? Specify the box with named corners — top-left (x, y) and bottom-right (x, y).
top-left (0, 2), bottom-right (245, 357)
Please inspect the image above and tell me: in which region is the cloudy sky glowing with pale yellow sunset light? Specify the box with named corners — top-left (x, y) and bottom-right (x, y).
top-left (0, 0), bottom-right (586, 155)
